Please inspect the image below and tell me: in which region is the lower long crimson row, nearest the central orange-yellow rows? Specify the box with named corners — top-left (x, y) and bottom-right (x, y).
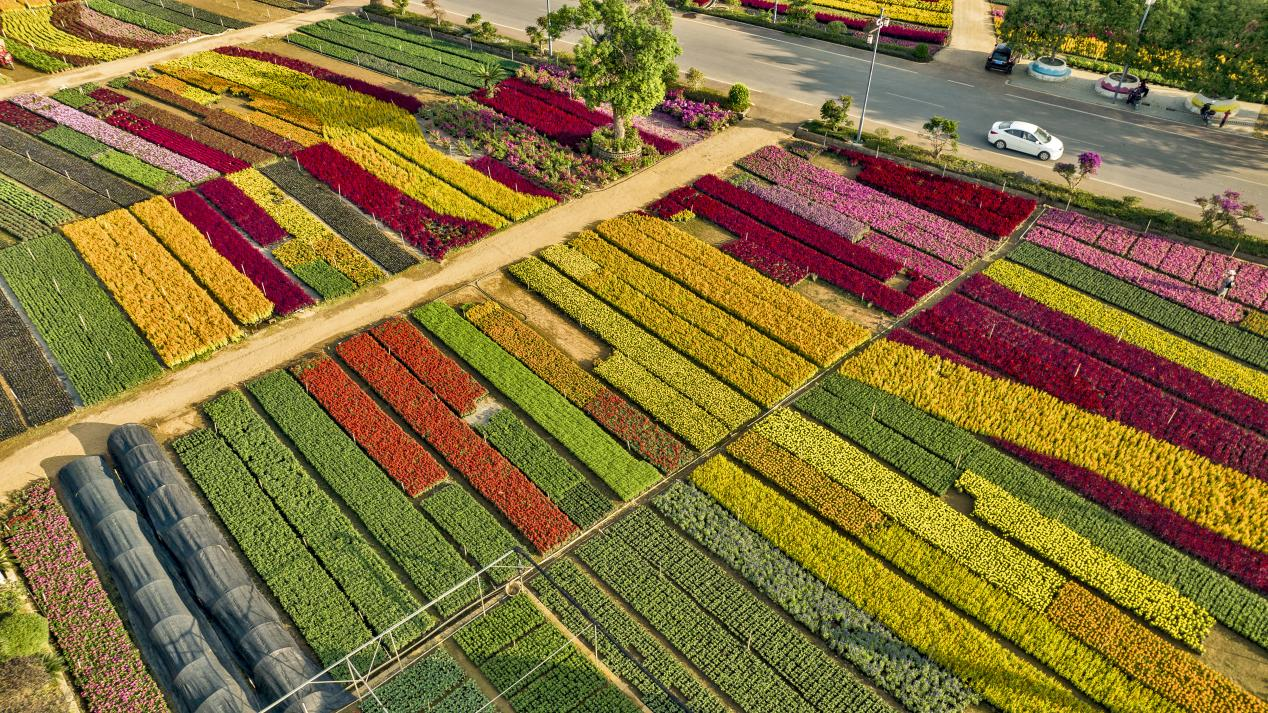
top-left (686, 182), bottom-right (915, 315)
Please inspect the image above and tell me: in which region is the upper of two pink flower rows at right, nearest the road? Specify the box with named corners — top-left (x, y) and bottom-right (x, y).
top-left (1038, 209), bottom-right (1268, 308)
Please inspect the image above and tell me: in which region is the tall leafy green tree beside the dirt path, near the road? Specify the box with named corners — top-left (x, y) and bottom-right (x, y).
top-left (548, 0), bottom-right (682, 145)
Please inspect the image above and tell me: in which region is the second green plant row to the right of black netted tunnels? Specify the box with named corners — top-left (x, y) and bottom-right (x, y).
top-left (203, 391), bottom-right (429, 644)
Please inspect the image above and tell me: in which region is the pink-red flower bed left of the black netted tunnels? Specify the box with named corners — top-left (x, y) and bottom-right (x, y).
top-left (4, 481), bottom-right (167, 713)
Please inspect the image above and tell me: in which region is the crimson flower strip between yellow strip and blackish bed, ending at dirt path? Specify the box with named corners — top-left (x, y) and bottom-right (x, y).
top-left (295, 143), bottom-right (493, 260)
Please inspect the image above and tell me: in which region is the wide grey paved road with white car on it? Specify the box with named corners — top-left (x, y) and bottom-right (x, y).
top-left (431, 0), bottom-right (1268, 225)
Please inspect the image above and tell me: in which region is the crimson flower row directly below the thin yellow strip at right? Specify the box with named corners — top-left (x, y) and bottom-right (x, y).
top-left (960, 274), bottom-right (1268, 435)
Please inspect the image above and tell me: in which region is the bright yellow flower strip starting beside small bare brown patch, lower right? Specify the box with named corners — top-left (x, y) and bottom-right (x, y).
top-left (956, 472), bottom-right (1215, 651)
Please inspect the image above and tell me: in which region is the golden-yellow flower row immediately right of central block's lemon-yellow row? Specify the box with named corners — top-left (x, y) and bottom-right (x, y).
top-left (541, 238), bottom-right (791, 406)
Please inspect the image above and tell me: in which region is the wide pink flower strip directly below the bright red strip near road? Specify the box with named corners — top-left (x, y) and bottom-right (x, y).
top-left (739, 146), bottom-right (992, 268)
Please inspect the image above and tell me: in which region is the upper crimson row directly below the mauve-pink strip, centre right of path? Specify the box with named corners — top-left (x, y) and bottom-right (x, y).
top-left (692, 175), bottom-right (903, 280)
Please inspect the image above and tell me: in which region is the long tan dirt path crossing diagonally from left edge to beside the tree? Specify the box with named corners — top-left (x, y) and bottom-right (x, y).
top-left (0, 122), bottom-right (787, 494)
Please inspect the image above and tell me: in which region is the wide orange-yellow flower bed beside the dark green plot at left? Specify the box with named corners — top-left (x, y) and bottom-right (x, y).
top-left (62, 209), bottom-right (242, 367)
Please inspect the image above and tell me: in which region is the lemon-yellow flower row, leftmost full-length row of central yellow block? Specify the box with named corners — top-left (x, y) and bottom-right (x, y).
top-left (508, 254), bottom-right (760, 429)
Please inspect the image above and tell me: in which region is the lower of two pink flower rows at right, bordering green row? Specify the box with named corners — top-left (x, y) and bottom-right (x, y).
top-left (1026, 226), bottom-right (1243, 322)
